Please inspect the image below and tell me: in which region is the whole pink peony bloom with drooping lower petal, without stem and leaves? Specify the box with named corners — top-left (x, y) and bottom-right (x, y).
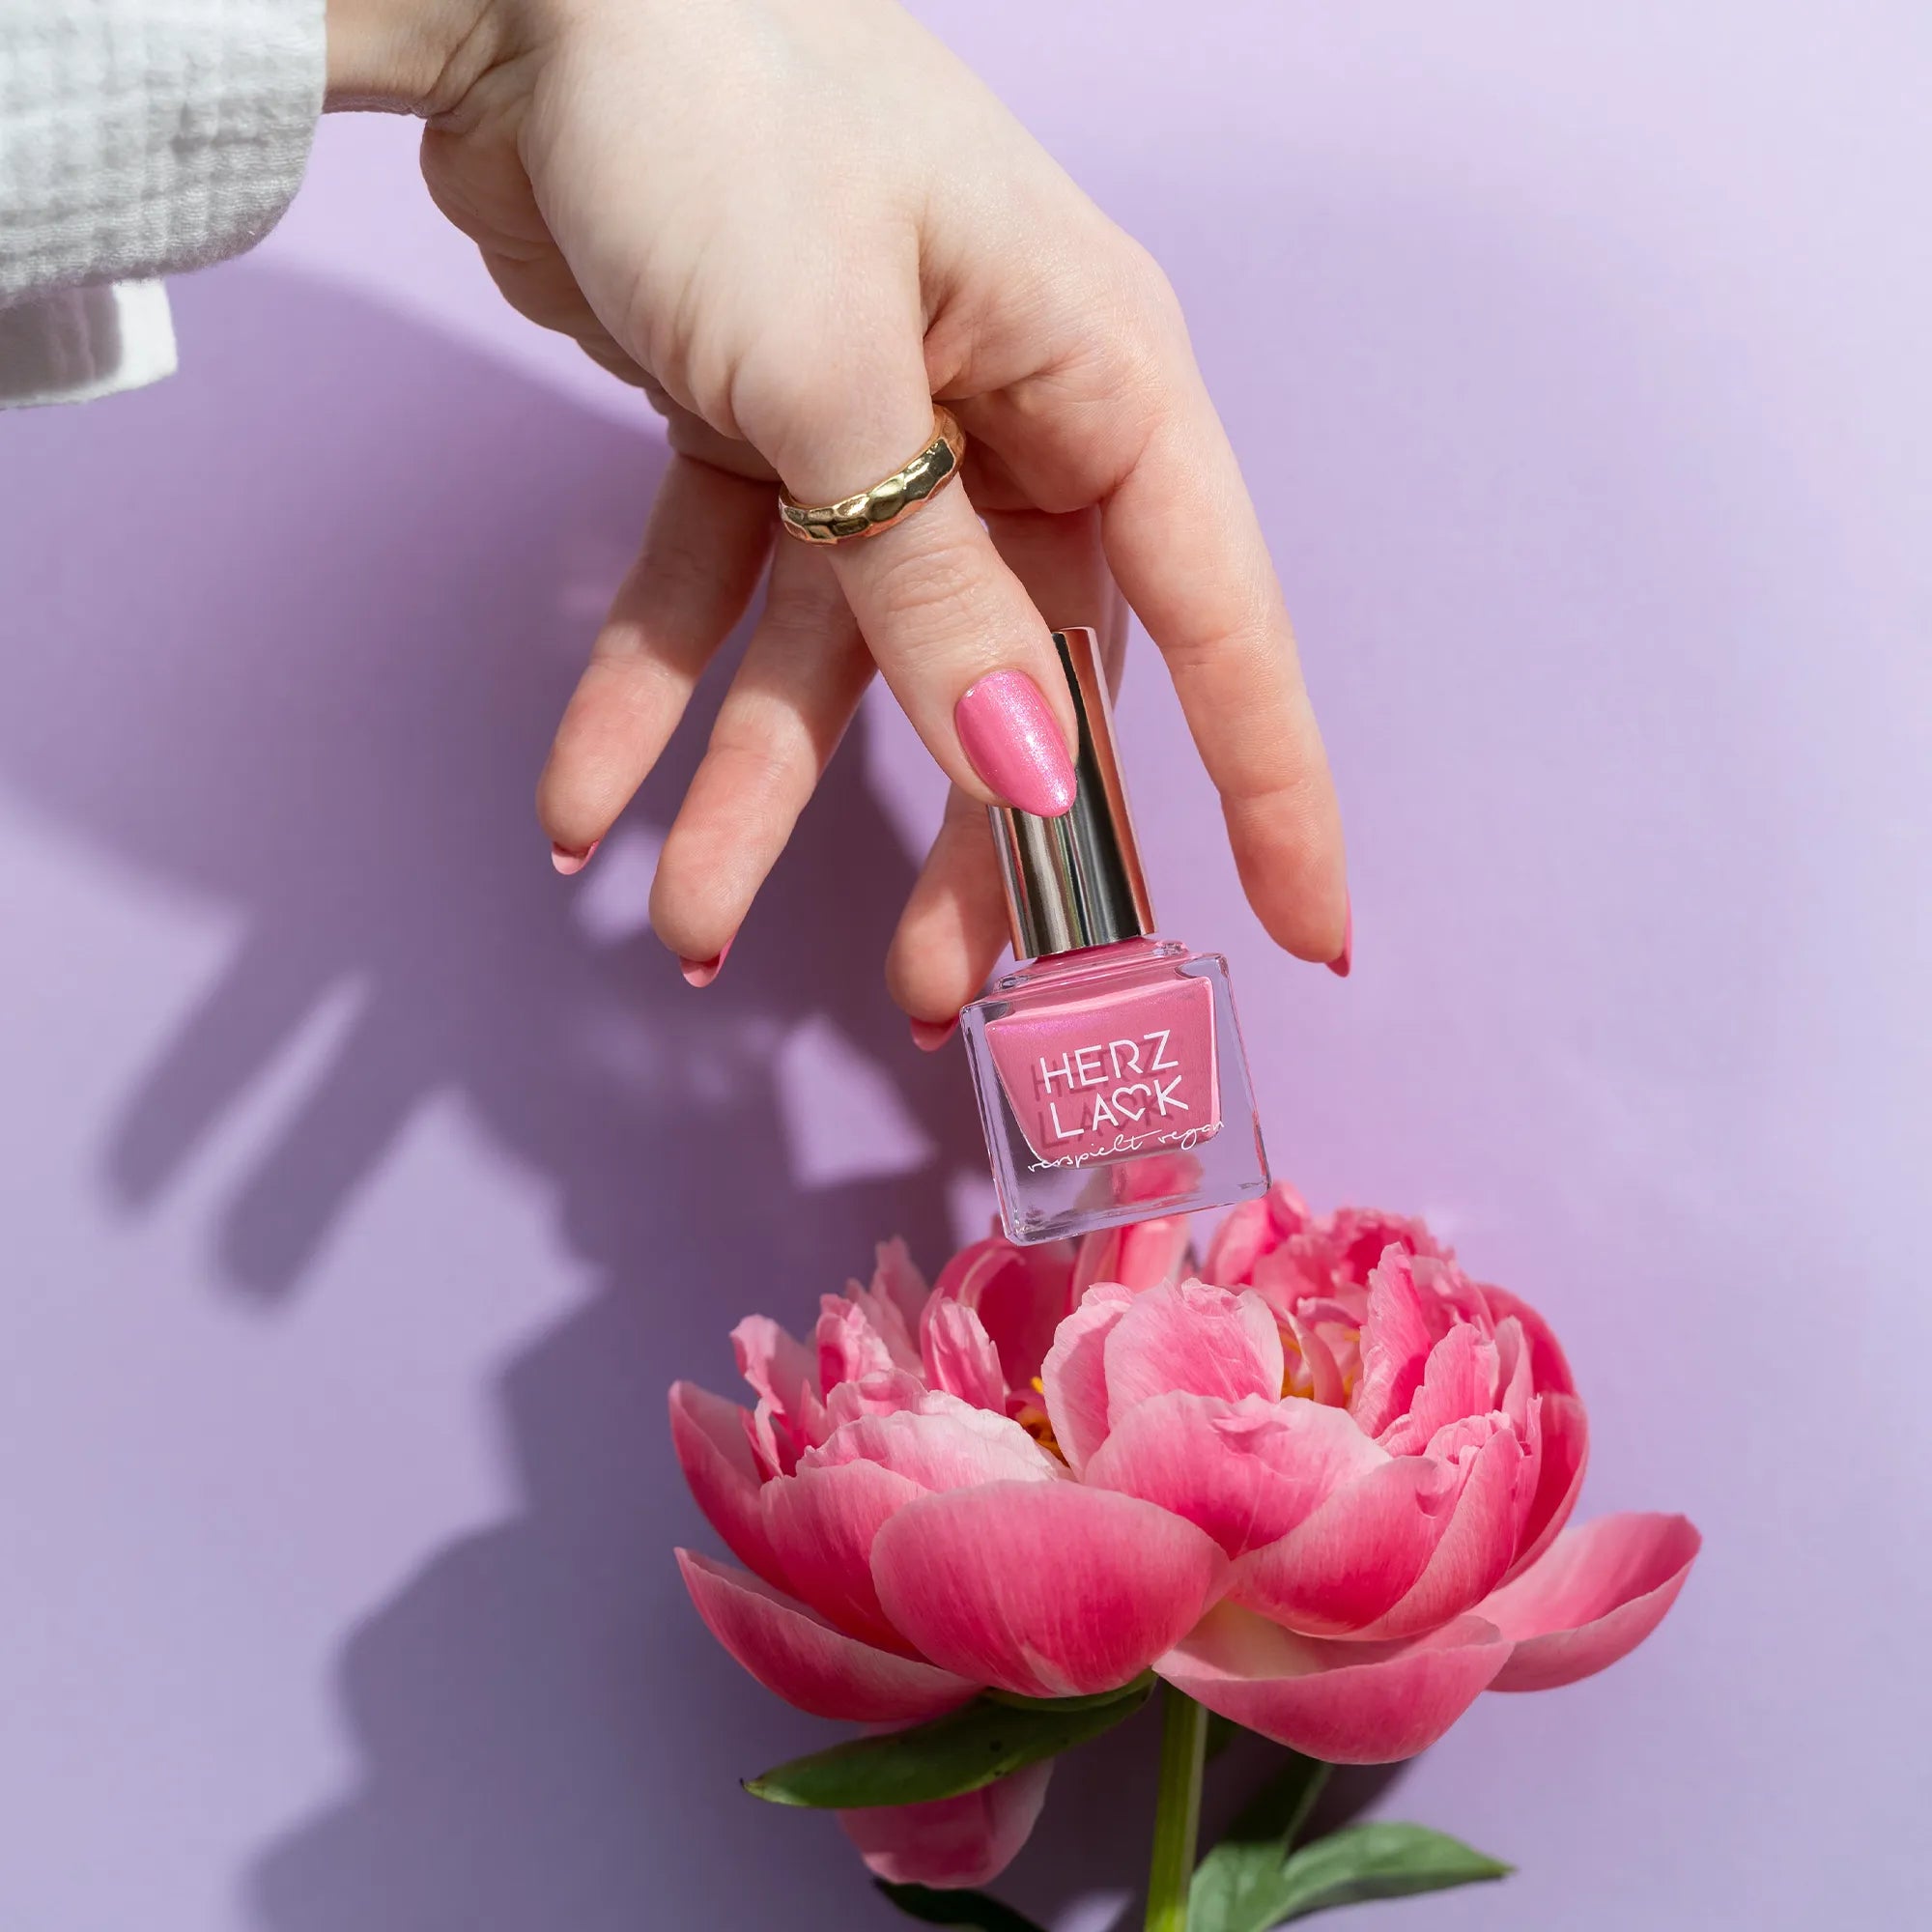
top-left (670, 1186), bottom-right (1698, 1886)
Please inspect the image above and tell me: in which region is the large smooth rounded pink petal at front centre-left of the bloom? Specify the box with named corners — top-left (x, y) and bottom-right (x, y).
top-left (871, 1482), bottom-right (1227, 1696)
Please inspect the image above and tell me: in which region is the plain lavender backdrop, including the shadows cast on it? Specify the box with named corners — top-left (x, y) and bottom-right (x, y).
top-left (0, 0), bottom-right (1932, 1932)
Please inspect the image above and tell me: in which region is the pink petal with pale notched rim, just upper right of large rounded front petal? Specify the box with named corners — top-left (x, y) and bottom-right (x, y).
top-left (1086, 1393), bottom-right (1387, 1557)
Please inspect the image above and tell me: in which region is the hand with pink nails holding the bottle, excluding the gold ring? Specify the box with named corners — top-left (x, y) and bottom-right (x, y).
top-left (330, 0), bottom-right (1347, 1037)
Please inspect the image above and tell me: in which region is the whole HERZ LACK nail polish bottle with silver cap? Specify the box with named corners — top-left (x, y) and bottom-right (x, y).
top-left (960, 630), bottom-right (1267, 1242)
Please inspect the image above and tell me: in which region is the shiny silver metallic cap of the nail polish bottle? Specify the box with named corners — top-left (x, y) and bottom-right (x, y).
top-left (989, 630), bottom-right (1153, 958)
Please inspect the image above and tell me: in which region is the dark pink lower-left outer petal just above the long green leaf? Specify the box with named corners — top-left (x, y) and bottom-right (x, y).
top-left (678, 1549), bottom-right (978, 1723)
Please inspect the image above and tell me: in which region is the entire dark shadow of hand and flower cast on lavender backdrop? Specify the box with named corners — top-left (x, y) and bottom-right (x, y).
top-left (0, 263), bottom-right (1267, 1932)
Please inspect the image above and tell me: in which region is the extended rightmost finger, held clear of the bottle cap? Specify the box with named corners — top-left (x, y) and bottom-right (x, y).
top-left (1101, 346), bottom-right (1349, 972)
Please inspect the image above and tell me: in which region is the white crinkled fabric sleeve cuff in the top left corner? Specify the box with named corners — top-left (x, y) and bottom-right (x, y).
top-left (0, 0), bottom-right (325, 309)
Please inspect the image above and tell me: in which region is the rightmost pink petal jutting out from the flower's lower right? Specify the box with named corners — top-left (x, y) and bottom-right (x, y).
top-left (1478, 1515), bottom-right (1704, 1690)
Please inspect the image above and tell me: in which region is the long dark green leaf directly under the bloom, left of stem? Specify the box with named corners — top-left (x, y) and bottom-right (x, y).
top-left (746, 1677), bottom-right (1153, 1810)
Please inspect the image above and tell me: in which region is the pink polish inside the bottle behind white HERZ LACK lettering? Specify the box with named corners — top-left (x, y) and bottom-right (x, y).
top-left (985, 976), bottom-right (1221, 1171)
